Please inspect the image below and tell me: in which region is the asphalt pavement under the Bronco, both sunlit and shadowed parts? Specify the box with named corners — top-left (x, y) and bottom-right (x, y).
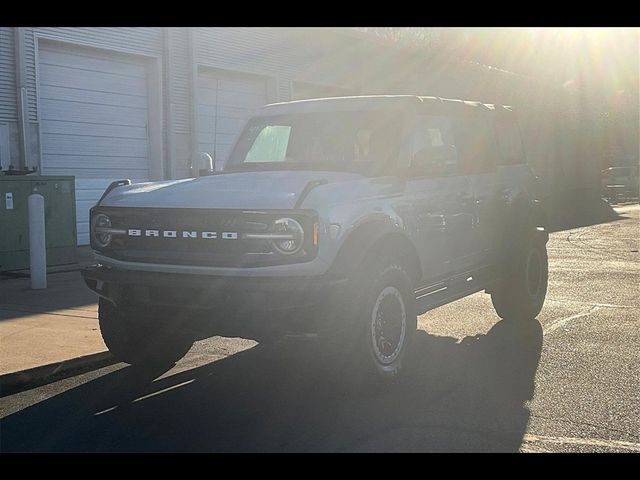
top-left (0, 205), bottom-right (640, 452)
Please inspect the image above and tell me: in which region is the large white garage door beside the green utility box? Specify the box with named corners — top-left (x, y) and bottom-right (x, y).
top-left (38, 46), bottom-right (149, 245)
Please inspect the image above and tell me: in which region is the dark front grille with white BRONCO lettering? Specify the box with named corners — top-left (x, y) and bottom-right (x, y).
top-left (92, 207), bottom-right (315, 267)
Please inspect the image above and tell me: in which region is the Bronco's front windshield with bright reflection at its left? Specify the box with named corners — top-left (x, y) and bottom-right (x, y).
top-left (226, 110), bottom-right (402, 174)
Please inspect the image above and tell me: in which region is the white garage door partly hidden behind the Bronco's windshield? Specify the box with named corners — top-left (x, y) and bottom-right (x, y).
top-left (198, 72), bottom-right (267, 166)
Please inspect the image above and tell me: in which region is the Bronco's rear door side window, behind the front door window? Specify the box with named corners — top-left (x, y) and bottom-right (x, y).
top-left (454, 116), bottom-right (499, 175)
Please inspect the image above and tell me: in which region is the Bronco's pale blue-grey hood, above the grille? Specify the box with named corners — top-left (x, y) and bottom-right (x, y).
top-left (100, 171), bottom-right (363, 210)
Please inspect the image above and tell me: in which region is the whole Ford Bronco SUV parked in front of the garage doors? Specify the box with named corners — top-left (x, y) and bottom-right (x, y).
top-left (82, 95), bottom-right (548, 379)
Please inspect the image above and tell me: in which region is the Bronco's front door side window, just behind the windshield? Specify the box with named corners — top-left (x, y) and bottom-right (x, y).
top-left (410, 115), bottom-right (458, 177)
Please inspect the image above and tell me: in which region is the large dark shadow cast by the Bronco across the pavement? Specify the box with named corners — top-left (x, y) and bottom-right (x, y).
top-left (0, 320), bottom-right (542, 452)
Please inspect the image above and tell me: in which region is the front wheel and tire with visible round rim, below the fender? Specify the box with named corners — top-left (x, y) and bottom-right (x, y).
top-left (319, 258), bottom-right (417, 383)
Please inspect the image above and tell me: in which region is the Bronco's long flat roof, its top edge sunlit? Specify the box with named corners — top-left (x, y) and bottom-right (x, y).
top-left (258, 95), bottom-right (511, 116)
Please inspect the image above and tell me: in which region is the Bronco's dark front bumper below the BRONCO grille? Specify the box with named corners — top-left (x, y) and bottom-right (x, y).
top-left (81, 265), bottom-right (347, 312)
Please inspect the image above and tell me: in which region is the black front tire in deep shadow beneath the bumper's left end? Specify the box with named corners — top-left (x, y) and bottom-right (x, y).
top-left (98, 298), bottom-right (194, 368)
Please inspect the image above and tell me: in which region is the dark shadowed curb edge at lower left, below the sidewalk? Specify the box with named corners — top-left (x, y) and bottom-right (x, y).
top-left (0, 351), bottom-right (117, 398)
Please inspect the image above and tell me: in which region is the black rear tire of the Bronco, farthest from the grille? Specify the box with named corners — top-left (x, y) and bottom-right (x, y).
top-left (491, 234), bottom-right (549, 320)
